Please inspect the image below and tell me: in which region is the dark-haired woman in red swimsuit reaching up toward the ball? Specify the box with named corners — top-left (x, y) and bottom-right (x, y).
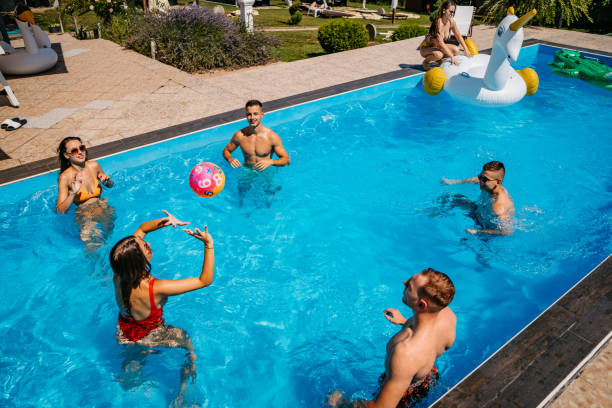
top-left (110, 210), bottom-right (215, 404)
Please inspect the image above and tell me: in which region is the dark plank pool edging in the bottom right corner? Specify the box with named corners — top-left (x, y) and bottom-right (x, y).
top-left (429, 254), bottom-right (612, 408)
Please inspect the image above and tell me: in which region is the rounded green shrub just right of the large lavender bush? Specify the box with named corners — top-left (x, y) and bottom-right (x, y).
top-left (317, 19), bottom-right (369, 53)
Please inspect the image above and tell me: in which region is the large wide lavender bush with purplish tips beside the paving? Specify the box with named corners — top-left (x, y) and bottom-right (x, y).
top-left (124, 7), bottom-right (278, 72)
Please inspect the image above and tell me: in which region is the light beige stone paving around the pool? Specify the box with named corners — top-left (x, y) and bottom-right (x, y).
top-left (0, 26), bottom-right (612, 407)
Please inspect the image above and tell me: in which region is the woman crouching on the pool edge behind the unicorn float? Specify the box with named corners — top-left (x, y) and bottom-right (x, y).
top-left (419, 0), bottom-right (472, 71)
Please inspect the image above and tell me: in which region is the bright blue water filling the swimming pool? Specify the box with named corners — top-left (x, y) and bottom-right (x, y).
top-left (0, 46), bottom-right (612, 407)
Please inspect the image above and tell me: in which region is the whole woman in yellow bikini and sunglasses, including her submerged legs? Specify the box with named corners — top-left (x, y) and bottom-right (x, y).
top-left (55, 136), bottom-right (115, 252)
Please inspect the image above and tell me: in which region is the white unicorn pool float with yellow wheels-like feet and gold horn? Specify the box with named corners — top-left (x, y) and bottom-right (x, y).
top-left (423, 7), bottom-right (539, 106)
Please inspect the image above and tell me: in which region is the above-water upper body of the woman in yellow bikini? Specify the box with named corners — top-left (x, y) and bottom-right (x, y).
top-left (55, 136), bottom-right (114, 214)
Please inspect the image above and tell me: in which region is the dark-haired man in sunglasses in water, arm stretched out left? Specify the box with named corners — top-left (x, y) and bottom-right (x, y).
top-left (441, 161), bottom-right (514, 235)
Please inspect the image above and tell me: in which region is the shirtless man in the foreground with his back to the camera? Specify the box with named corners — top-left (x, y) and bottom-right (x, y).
top-left (328, 268), bottom-right (457, 408)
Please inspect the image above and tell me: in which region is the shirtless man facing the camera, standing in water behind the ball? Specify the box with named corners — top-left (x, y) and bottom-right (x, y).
top-left (223, 99), bottom-right (289, 171)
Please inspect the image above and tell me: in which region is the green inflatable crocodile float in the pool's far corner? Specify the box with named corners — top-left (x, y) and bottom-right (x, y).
top-left (548, 50), bottom-right (612, 90)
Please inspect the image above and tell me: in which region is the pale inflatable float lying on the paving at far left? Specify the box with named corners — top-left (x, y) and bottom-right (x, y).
top-left (0, 18), bottom-right (57, 75)
